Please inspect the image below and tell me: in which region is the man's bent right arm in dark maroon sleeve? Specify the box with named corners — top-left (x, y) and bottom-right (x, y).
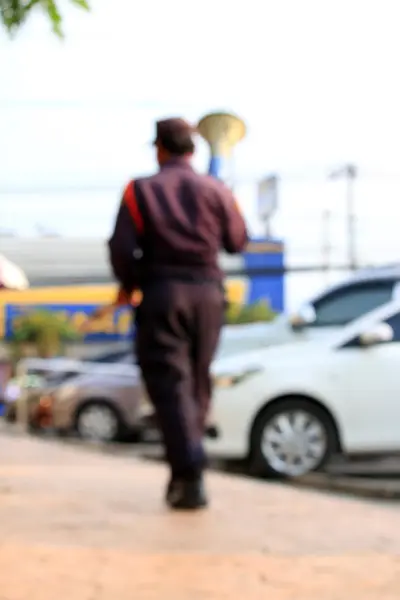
top-left (221, 188), bottom-right (249, 254)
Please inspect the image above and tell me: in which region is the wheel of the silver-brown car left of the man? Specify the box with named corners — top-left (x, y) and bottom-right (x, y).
top-left (76, 401), bottom-right (122, 442)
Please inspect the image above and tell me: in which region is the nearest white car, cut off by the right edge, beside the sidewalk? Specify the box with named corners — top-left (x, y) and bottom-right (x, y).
top-left (206, 300), bottom-right (400, 476)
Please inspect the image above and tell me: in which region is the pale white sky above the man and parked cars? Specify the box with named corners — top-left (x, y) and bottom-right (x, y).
top-left (0, 0), bottom-right (400, 263)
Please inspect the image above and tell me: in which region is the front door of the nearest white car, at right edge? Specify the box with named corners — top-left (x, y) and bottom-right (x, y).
top-left (334, 314), bottom-right (400, 452)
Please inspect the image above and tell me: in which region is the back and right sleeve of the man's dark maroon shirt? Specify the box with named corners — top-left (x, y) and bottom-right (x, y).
top-left (134, 159), bottom-right (247, 279)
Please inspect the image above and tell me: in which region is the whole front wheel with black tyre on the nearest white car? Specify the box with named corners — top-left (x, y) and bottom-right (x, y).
top-left (250, 398), bottom-right (339, 477)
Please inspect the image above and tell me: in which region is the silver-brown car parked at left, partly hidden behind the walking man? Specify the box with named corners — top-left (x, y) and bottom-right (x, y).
top-left (18, 351), bottom-right (150, 441)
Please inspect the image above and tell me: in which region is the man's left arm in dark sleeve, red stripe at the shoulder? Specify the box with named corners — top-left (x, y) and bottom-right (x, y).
top-left (108, 182), bottom-right (141, 295)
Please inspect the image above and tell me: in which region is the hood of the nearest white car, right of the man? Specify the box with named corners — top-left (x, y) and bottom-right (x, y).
top-left (212, 341), bottom-right (330, 376)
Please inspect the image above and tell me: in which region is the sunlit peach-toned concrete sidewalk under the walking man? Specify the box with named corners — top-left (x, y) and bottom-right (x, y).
top-left (0, 433), bottom-right (400, 600)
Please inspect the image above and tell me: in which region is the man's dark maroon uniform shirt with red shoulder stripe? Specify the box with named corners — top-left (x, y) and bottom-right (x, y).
top-left (109, 158), bottom-right (248, 293)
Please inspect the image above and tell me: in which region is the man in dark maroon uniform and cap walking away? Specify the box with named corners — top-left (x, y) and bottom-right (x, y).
top-left (109, 119), bottom-right (247, 509)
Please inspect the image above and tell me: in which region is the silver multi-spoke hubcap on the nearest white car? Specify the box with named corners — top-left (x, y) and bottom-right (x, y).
top-left (261, 410), bottom-right (327, 477)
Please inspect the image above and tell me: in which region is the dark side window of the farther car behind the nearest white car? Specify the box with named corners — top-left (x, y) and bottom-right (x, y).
top-left (312, 282), bottom-right (393, 327)
